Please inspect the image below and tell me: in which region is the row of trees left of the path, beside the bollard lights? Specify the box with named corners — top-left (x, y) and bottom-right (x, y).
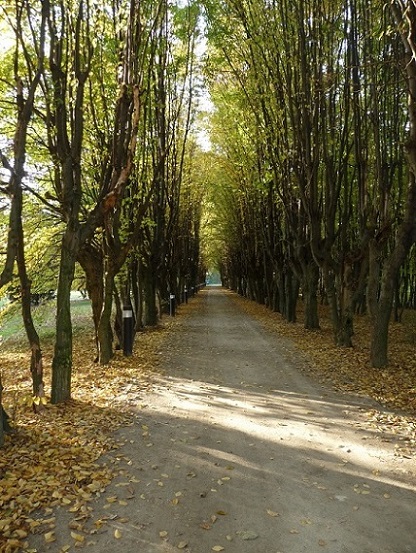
top-left (0, 0), bottom-right (207, 444)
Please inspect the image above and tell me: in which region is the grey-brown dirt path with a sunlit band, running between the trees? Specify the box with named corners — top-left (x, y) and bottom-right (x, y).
top-left (31, 287), bottom-right (416, 553)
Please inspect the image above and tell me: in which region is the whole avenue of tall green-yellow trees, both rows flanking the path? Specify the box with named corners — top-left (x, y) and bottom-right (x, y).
top-left (0, 0), bottom-right (416, 442)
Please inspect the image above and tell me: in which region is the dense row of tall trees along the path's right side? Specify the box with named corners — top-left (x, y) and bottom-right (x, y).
top-left (205, 0), bottom-right (416, 367)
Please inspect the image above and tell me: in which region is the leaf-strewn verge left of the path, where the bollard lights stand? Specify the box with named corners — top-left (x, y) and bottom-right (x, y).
top-left (0, 304), bottom-right (173, 553)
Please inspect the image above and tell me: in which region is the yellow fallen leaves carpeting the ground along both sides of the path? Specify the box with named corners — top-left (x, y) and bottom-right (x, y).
top-left (0, 294), bottom-right (416, 553)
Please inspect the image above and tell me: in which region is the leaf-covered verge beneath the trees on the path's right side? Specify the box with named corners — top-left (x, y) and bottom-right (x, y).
top-left (234, 298), bottom-right (416, 457)
